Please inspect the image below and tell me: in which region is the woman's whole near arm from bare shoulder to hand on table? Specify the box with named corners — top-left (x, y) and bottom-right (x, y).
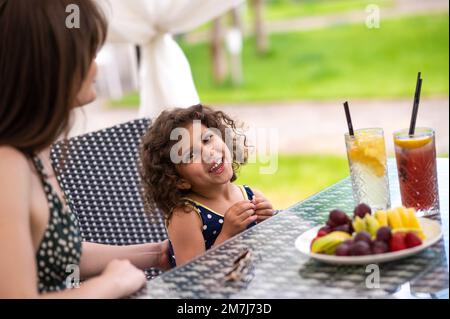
top-left (0, 147), bottom-right (146, 298)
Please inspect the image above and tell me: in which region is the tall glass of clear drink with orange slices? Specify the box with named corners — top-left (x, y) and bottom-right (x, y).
top-left (345, 128), bottom-right (391, 210)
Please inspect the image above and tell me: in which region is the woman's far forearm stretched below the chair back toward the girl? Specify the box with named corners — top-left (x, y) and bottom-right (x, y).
top-left (80, 241), bottom-right (170, 278)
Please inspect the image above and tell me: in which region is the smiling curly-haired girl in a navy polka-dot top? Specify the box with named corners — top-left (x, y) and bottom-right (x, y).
top-left (141, 105), bottom-right (274, 266)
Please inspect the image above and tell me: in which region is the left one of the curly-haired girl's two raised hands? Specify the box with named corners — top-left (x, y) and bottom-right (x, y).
top-left (221, 200), bottom-right (257, 238)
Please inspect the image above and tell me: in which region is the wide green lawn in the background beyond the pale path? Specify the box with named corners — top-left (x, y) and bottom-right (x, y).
top-left (114, 14), bottom-right (449, 106)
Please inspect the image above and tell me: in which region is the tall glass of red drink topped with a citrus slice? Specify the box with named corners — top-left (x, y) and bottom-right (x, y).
top-left (394, 127), bottom-right (439, 215)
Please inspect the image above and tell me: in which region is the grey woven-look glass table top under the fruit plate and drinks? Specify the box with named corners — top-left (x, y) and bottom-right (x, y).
top-left (135, 159), bottom-right (449, 299)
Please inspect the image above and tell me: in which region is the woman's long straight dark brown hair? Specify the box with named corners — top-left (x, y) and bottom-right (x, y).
top-left (0, 0), bottom-right (107, 154)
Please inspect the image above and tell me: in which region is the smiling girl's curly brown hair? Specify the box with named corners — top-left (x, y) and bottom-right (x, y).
top-left (140, 104), bottom-right (248, 220)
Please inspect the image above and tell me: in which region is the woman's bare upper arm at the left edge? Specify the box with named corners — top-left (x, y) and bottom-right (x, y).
top-left (0, 147), bottom-right (37, 298)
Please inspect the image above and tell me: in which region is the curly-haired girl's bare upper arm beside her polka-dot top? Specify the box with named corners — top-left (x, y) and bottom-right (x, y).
top-left (167, 209), bottom-right (205, 266)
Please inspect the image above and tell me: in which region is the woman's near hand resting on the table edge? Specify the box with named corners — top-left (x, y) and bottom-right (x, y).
top-left (101, 259), bottom-right (147, 297)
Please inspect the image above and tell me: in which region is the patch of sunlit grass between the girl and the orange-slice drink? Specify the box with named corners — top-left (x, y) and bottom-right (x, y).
top-left (237, 155), bottom-right (348, 209)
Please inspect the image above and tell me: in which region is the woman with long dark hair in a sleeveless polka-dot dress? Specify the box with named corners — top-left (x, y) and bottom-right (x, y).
top-left (0, 0), bottom-right (168, 298)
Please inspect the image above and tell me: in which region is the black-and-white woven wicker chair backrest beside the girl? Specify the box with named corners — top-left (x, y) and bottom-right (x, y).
top-left (51, 119), bottom-right (167, 275)
